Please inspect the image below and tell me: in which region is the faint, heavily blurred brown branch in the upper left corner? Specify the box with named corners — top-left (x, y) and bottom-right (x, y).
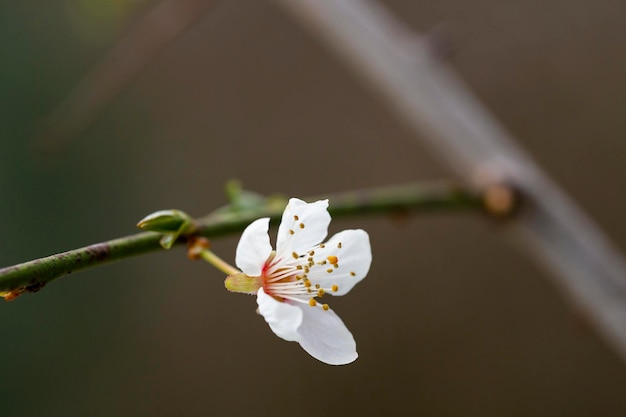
top-left (33, 0), bottom-right (217, 151)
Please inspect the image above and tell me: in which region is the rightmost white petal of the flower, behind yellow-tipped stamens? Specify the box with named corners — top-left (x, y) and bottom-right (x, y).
top-left (308, 229), bottom-right (372, 295)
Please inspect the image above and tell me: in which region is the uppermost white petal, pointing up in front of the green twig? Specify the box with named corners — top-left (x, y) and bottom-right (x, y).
top-left (276, 198), bottom-right (330, 254)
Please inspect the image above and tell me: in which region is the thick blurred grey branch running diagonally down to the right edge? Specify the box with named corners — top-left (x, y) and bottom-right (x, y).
top-left (275, 0), bottom-right (626, 360)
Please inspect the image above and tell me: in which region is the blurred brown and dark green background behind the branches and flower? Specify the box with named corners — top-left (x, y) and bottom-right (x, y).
top-left (0, 0), bottom-right (626, 417)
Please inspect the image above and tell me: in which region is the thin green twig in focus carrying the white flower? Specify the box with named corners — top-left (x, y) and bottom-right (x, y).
top-left (0, 182), bottom-right (484, 300)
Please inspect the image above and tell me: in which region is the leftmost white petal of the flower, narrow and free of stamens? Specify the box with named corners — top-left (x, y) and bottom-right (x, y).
top-left (235, 218), bottom-right (272, 277)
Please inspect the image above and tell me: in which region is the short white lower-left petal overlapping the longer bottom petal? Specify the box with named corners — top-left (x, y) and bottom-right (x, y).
top-left (256, 288), bottom-right (303, 342)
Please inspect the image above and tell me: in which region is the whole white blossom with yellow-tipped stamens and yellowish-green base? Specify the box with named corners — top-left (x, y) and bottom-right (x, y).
top-left (226, 198), bottom-right (372, 365)
